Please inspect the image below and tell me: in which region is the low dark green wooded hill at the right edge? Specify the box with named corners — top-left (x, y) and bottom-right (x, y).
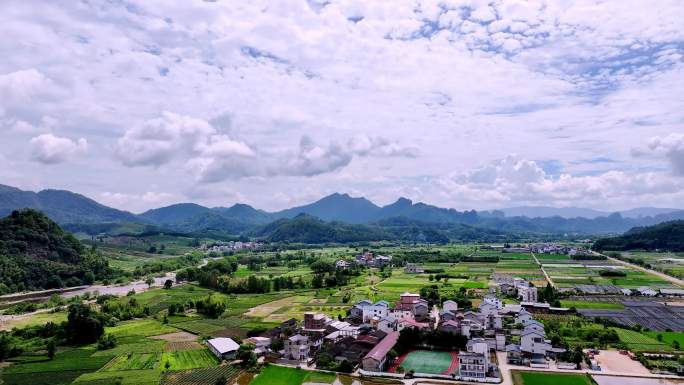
top-left (593, 220), bottom-right (684, 251)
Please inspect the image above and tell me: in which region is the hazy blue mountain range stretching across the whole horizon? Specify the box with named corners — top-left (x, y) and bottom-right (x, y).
top-left (0, 185), bottom-right (684, 239)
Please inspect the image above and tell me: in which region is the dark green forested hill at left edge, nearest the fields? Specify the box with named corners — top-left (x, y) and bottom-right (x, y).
top-left (0, 209), bottom-right (109, 293)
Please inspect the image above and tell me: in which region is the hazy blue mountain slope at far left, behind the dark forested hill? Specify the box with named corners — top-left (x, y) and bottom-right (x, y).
top-left (0, 185), bottom-right (140, 223)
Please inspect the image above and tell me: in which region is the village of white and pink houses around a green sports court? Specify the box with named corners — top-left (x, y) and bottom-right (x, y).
top-left (207, 272), bottom-right (579, 382)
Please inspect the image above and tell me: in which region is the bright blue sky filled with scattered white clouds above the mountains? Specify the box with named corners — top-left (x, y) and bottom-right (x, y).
top-left (0, 0), bottom-right (684, 212)
